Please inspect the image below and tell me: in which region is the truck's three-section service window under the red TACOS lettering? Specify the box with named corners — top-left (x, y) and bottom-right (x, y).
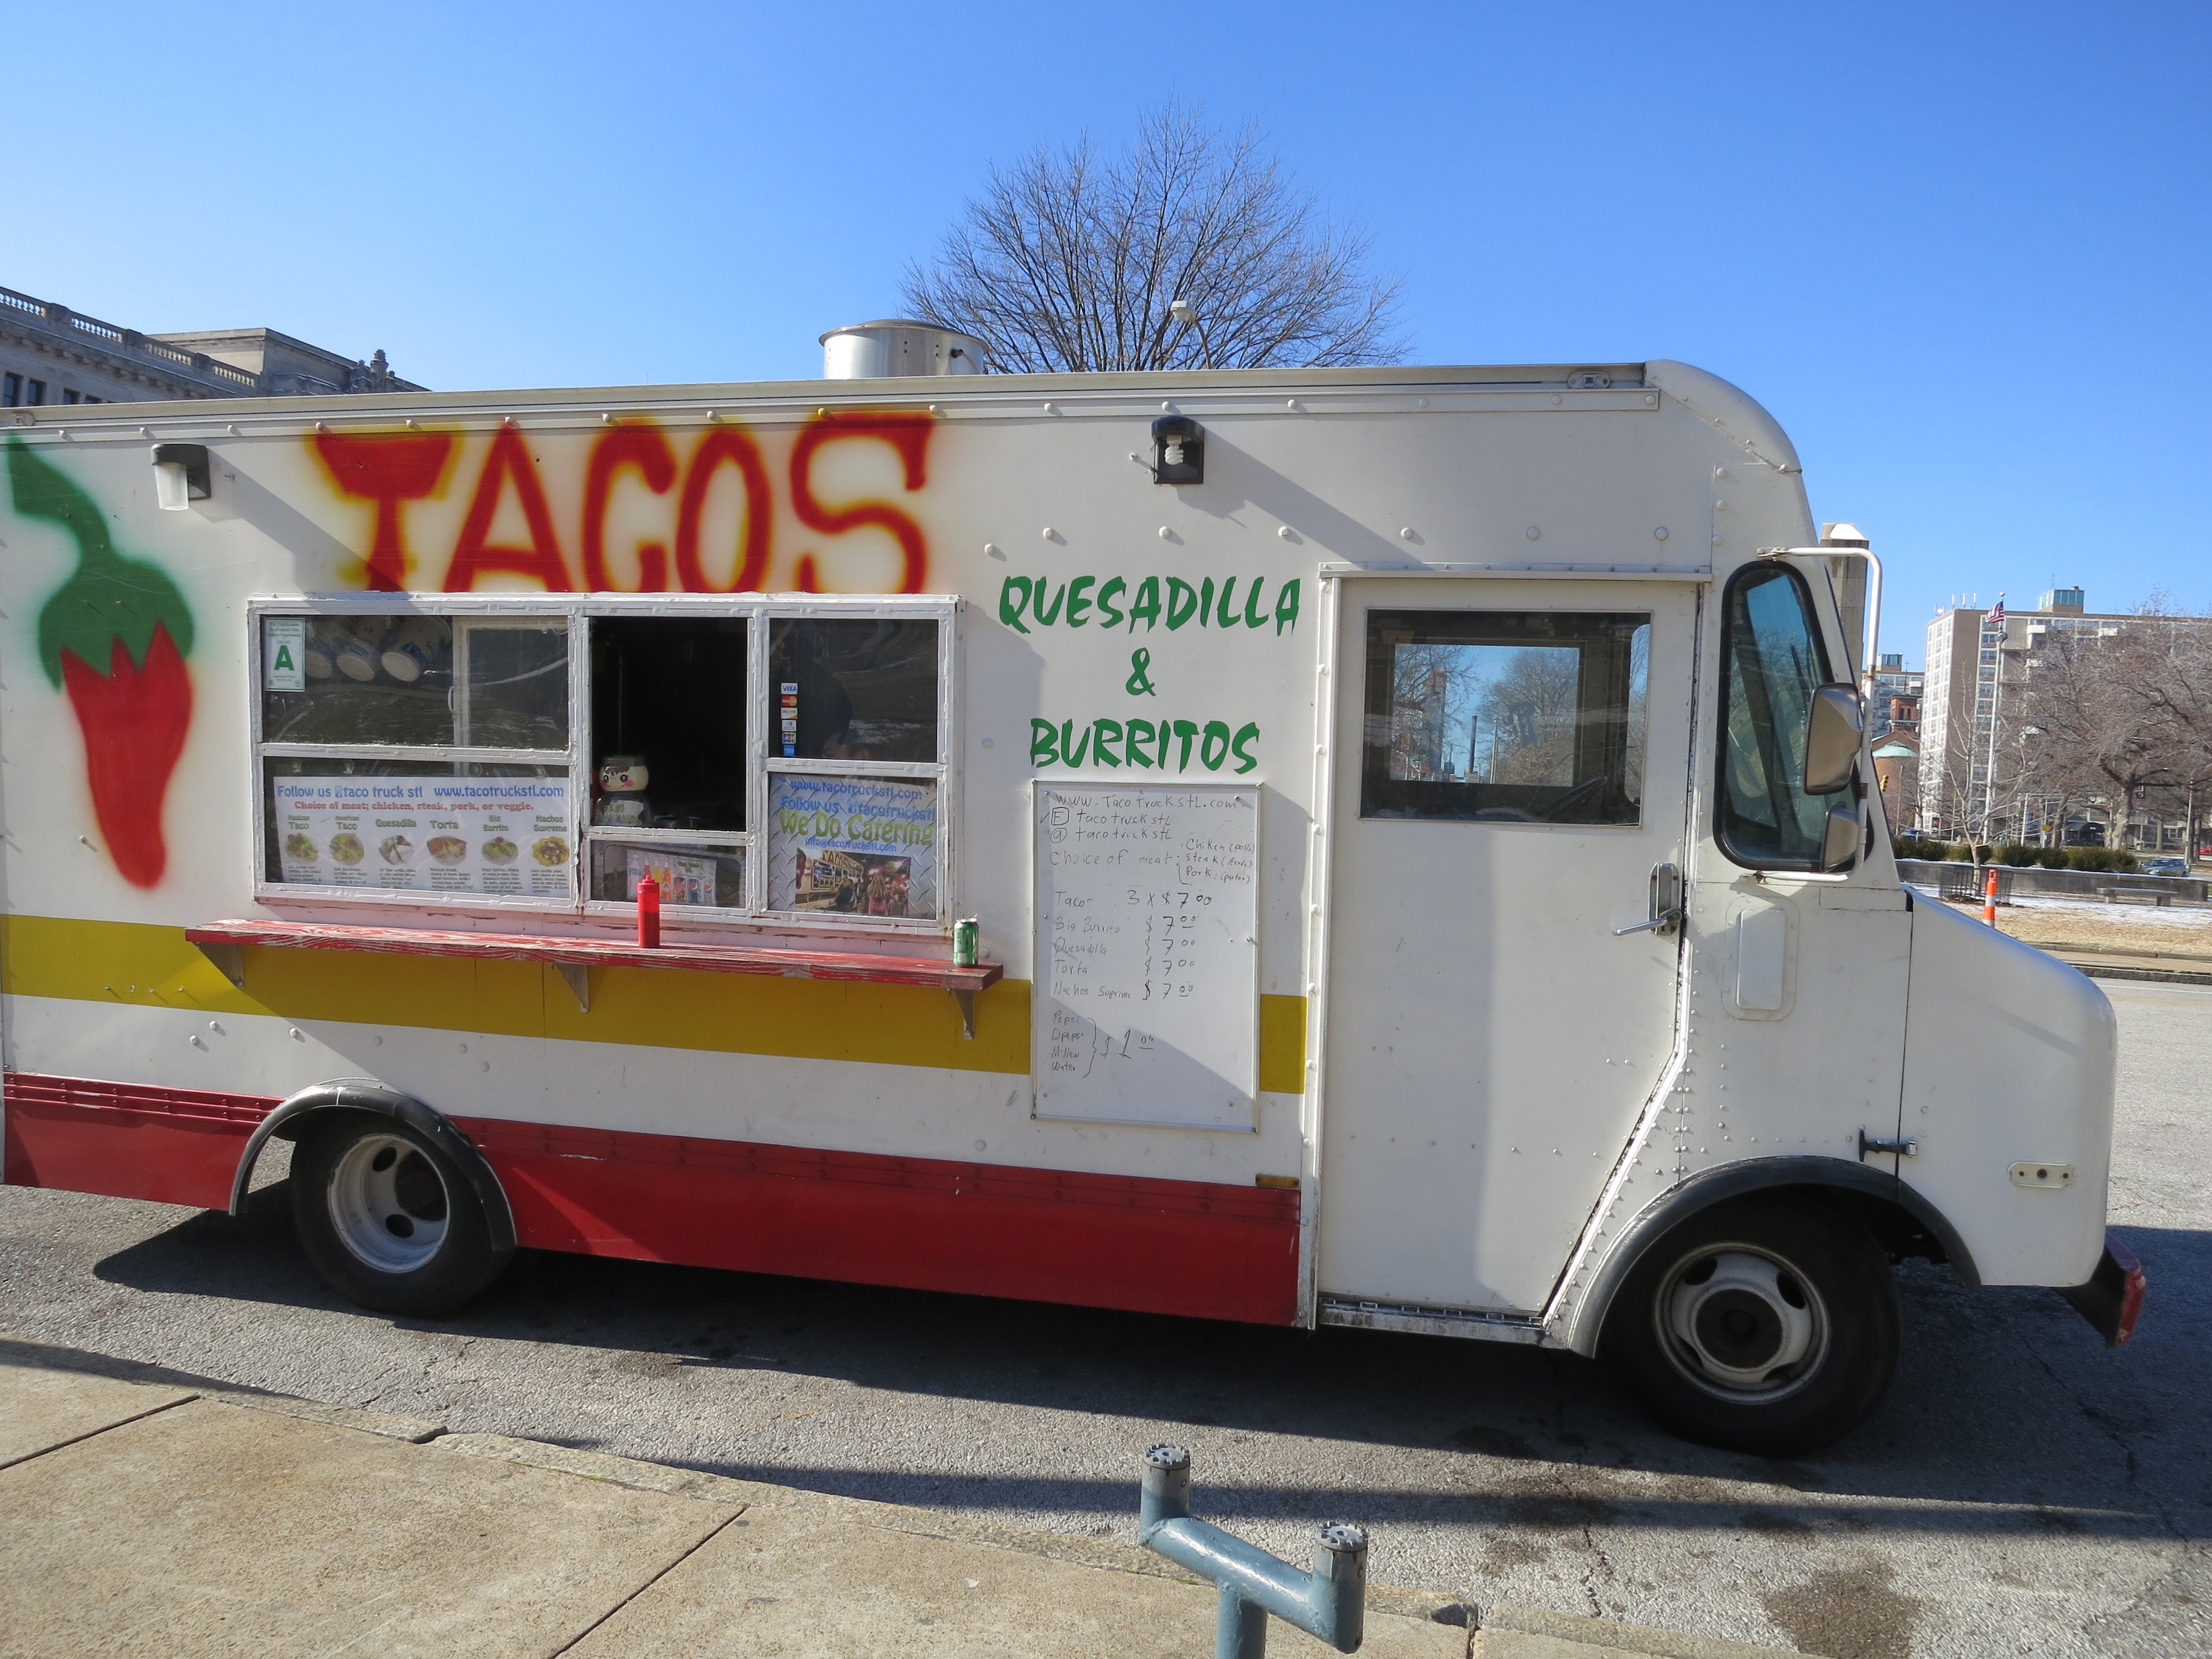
top-left (252, 595), bottom-right (951, 927)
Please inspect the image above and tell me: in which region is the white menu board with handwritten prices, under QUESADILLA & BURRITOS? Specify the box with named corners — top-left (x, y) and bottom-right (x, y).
top-left (1031, 783), bottom-right (1259, 1130)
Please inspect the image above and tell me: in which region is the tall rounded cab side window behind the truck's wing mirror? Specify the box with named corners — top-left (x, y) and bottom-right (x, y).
top-left (1717, 564), bottom-right (1829, 869)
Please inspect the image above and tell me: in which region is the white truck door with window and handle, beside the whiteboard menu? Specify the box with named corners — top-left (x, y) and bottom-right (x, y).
top-left (1316, 577), bottom-right (1701, 1318)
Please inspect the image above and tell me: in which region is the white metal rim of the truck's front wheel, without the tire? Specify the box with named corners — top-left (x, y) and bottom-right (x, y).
top-left (1652, 1243), bottom-right (1829, 1405)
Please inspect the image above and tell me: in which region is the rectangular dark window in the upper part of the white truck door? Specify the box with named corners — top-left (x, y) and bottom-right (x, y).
top-left (1360, 611), bottom-right (1650, 823)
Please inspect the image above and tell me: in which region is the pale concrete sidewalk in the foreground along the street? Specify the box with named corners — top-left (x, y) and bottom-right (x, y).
top-left (0, 1338), bottom-right (1778, 1659)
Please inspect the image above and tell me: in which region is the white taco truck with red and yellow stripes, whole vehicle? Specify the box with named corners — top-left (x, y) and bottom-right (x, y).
top-left (0, 334), bottom-right (2143, 1451)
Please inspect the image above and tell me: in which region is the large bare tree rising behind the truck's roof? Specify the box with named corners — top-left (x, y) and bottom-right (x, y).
top-left (902, 104), bottom-right (1405, 372)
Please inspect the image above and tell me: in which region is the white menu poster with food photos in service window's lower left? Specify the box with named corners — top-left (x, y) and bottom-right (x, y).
top-left (270, 779), bottom-right (573, 898)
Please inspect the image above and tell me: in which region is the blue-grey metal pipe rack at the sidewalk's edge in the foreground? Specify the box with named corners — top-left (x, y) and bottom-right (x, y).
top-left (1137, 1444), bottom-right (1367, 1659)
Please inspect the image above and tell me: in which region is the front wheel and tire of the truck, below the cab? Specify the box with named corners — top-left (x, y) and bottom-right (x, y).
top-left (1599, 1197), bottom-right (1898, 1458)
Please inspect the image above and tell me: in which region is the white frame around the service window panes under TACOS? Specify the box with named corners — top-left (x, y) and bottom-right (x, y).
top-left (246, 593), bottom-right (962, 936)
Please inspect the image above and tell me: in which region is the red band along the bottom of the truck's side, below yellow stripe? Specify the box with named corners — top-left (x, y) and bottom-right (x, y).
top-left (4, 1073), bottom-right (1298, 1325)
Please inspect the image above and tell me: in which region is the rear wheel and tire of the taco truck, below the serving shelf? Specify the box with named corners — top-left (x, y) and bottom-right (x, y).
top-left (292, 1113), bottom-right (513, 1316)
